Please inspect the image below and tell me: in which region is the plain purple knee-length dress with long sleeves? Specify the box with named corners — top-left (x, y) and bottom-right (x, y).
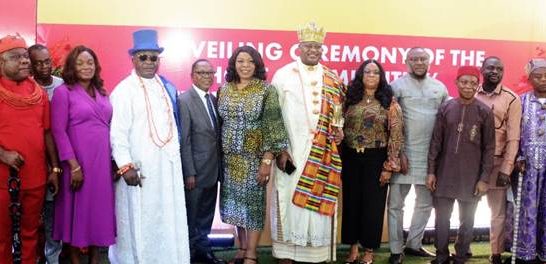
top-left (51, 85), bottom-right (116, 247)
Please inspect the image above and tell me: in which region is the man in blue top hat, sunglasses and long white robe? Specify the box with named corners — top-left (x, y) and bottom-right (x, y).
top-left (109, 27), bottom-right (190, 264)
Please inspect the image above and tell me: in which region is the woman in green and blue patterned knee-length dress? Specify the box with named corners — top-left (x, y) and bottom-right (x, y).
top-left (218, 46), bottom-right (288, 263)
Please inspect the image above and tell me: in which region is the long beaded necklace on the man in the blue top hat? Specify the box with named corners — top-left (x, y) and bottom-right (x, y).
top-left (138, 76), bottom-right (174, 148)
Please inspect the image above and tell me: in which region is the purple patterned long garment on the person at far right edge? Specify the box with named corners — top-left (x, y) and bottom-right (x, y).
top-left (516, 91), bottom-right (546, 261)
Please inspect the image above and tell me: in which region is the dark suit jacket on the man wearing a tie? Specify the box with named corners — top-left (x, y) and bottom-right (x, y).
top-left (178, 87), bottom-right (221, 188)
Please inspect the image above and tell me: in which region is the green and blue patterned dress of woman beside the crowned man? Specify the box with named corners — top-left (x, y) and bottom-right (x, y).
top-left (218, 79), bottom-right (288, 230)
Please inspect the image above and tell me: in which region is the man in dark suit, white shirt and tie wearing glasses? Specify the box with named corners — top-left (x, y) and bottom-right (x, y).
top-left (178, 59), bottom-right (225, 264)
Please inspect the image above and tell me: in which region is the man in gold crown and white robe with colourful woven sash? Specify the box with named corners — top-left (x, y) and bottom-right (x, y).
top-left (271, 23), bottom-right (345, 263)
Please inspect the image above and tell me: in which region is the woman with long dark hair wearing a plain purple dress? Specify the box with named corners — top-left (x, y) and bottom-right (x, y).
top-left (51, 46), bottom-right (116, 263)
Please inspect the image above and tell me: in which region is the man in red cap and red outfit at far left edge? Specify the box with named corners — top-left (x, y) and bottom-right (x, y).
top-left (0, 35), bottom-right (61, 263)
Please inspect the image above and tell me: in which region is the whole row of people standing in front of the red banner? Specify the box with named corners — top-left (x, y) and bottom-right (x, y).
top-left (0, 20), bottom-right (546, 264)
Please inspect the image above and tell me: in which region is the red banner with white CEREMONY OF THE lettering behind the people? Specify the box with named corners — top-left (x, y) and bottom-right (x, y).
top-left (37, 24), bottom-right (546, 95)
